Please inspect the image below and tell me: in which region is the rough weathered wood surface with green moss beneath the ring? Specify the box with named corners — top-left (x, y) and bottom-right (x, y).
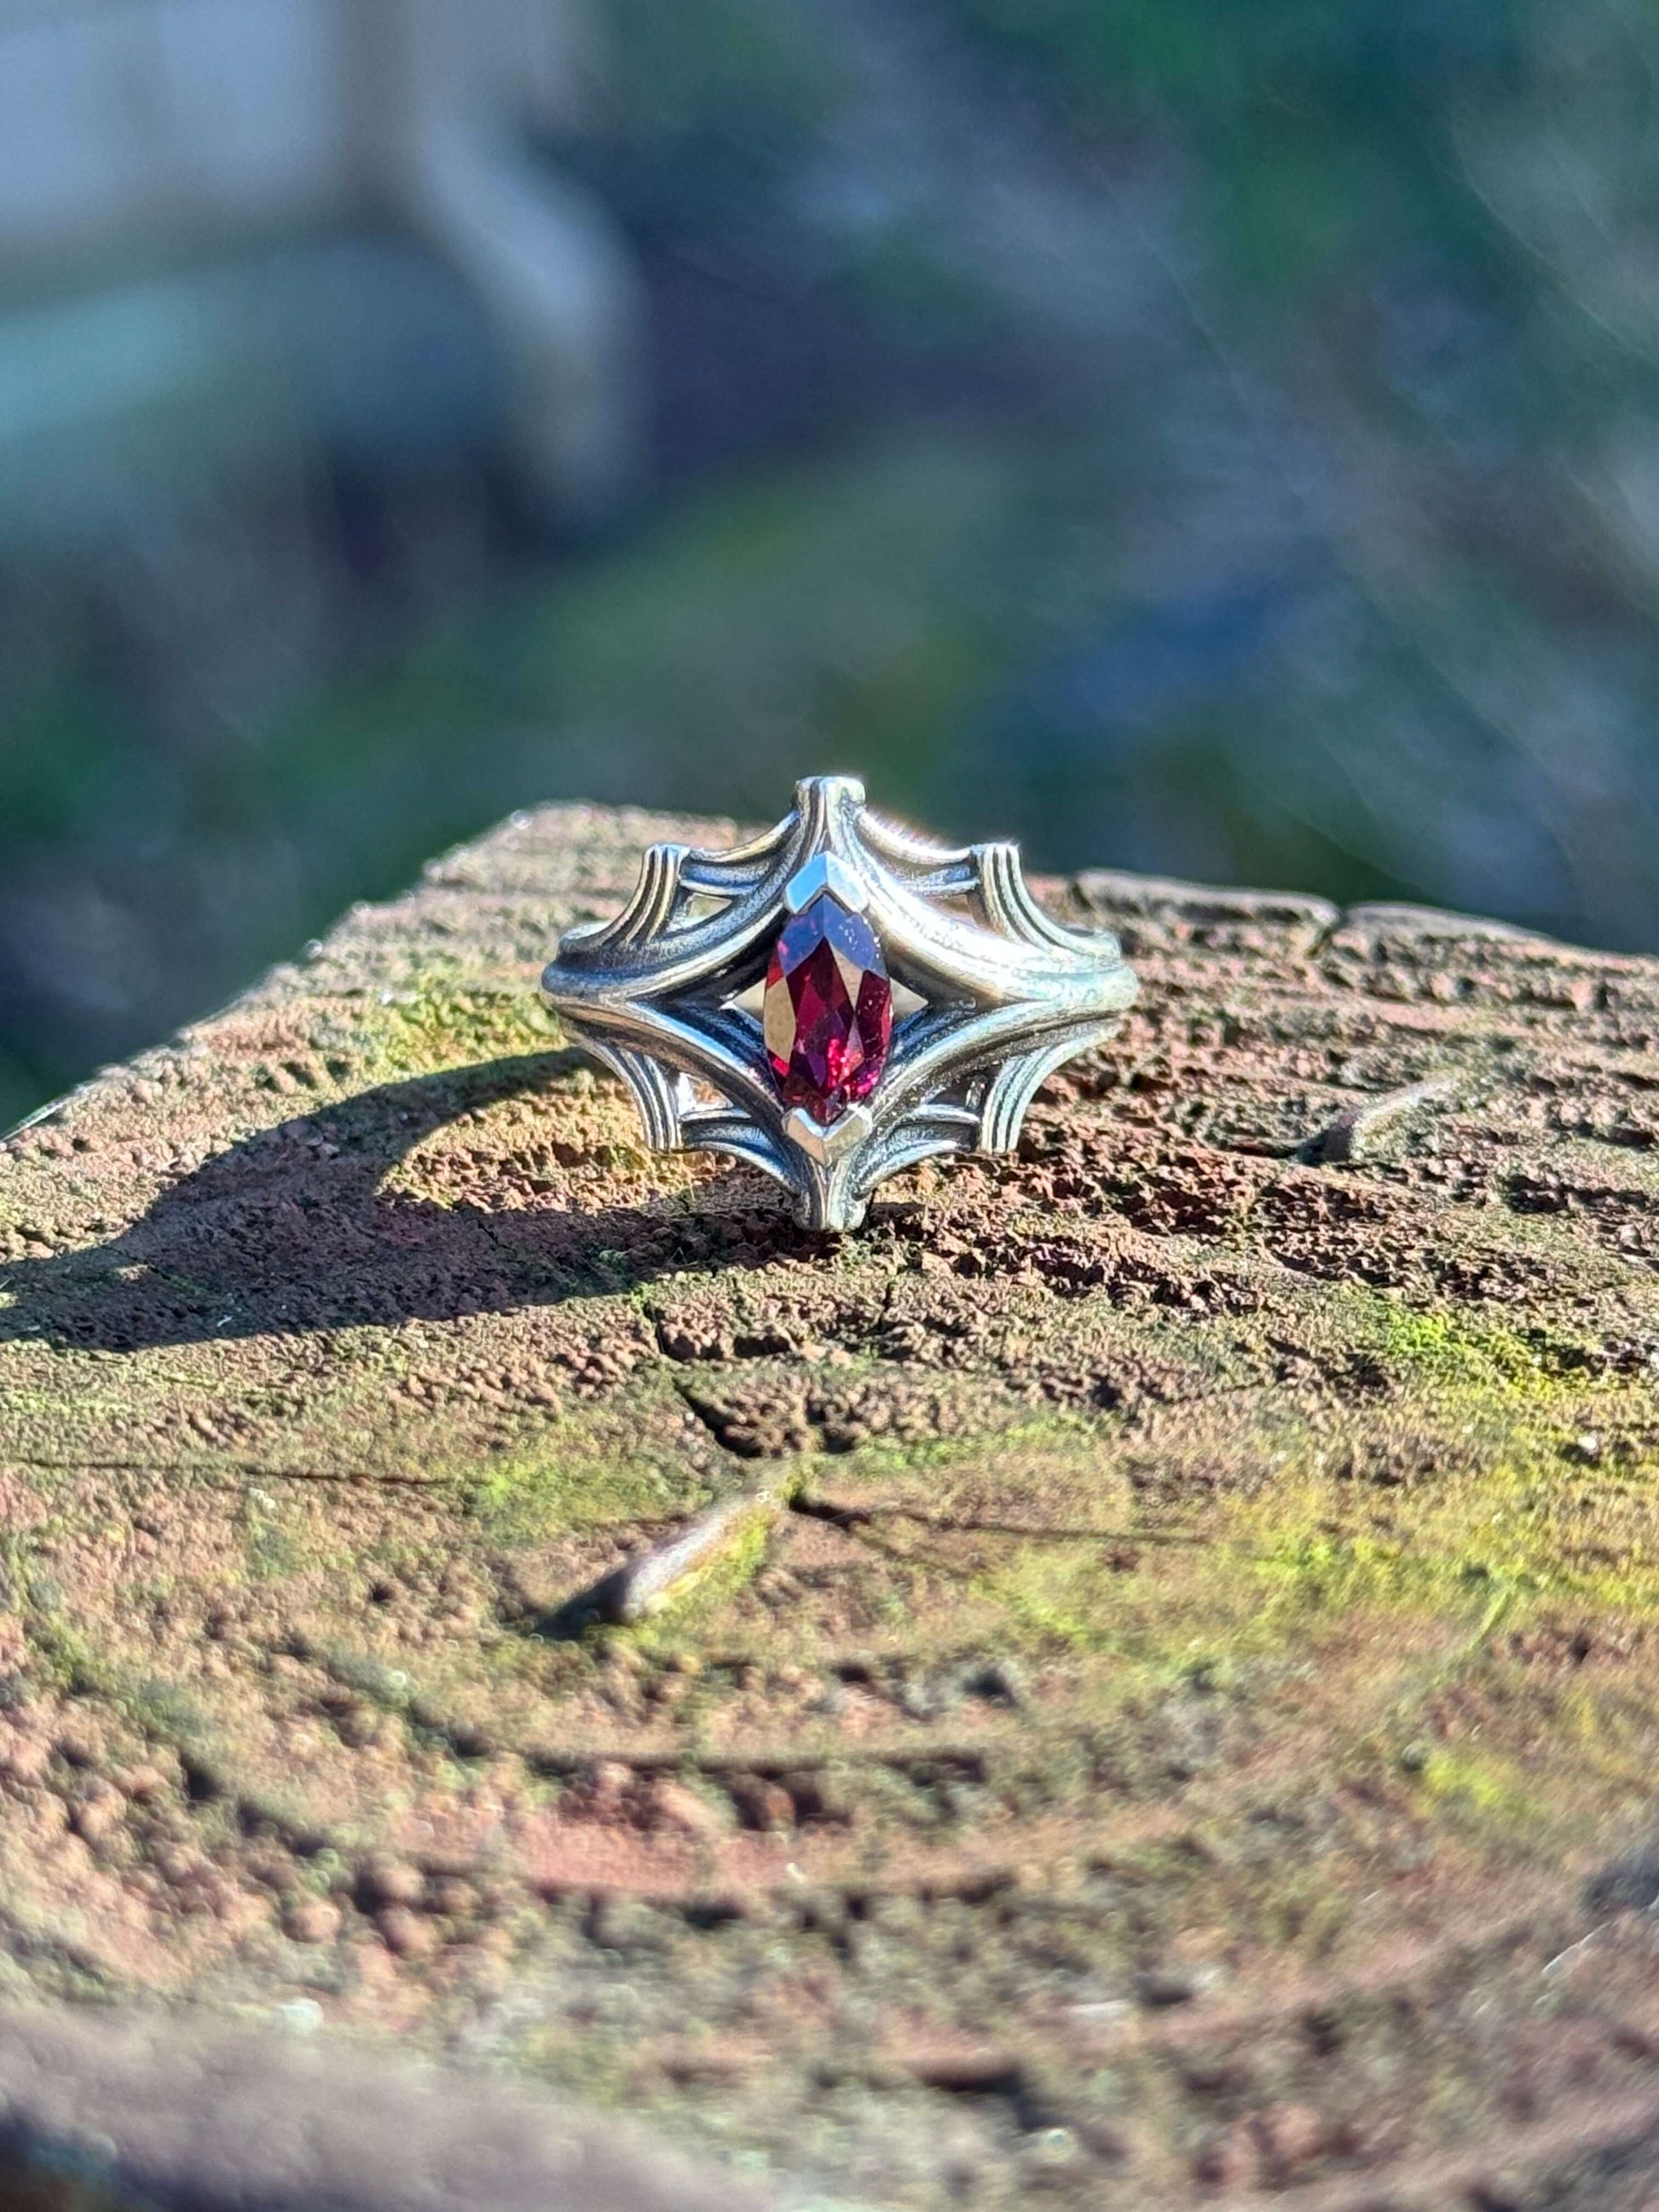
top-left (0, 807), bottom-right (1659, 2208)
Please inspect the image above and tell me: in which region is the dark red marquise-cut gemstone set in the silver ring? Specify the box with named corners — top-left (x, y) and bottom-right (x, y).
top-left (761, 892), bottom-right (893, 1128)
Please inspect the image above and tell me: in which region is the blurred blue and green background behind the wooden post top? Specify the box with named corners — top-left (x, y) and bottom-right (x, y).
top-left (0, 0), bottom-right (1659, 1123)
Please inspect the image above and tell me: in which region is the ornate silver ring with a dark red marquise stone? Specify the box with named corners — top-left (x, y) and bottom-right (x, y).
top-left (542, 777), bottom-right (1139, 1230)
